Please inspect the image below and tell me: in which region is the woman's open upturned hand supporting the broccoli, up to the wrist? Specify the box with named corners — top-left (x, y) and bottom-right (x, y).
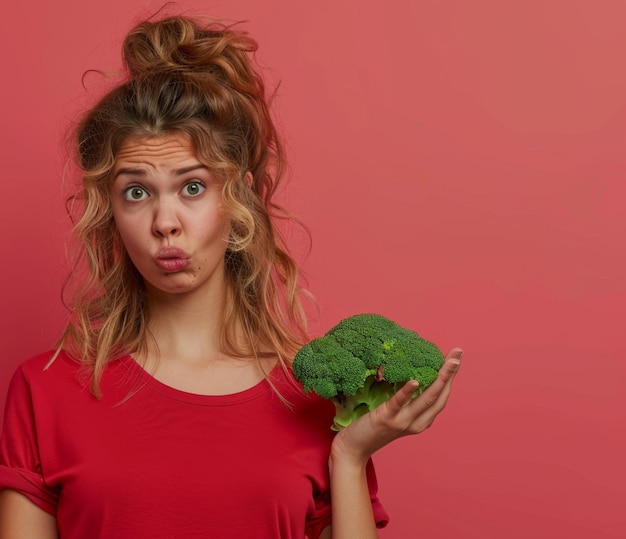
top-left (331, 348), bottom-right (463, 465)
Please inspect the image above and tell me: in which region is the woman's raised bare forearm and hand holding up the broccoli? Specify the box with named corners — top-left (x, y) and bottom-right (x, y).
top-left (320, 348), bottom-right (462, 539)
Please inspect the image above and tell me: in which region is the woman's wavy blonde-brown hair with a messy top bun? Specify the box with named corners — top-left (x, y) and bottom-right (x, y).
top-left (57, 16), bottom-right (307, 395)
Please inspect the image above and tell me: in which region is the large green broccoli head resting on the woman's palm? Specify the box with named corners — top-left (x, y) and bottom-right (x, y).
top-left (293, 314), bottom-right (444, 431)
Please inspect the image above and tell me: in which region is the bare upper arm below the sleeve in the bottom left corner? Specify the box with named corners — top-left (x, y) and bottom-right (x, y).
top-left (0, 489), bottom-right (58, 539)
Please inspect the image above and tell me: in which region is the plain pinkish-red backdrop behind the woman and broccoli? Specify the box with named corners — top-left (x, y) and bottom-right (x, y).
top-left (0, 0), bottom-right (626, 539)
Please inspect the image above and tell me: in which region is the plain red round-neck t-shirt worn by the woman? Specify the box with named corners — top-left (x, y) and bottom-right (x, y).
top-left (0, 353), bottom-right (388, 539)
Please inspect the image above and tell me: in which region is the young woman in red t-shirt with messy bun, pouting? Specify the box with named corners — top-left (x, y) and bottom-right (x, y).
top-left (0, 13), bottom-right (461, 539)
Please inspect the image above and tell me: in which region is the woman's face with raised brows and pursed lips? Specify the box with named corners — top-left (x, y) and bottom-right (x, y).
top-left (111, 134), bottom-right (230, 300)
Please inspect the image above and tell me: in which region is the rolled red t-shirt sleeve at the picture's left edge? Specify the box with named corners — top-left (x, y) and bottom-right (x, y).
top-left (0, 368), bottom-right (58, 515)
